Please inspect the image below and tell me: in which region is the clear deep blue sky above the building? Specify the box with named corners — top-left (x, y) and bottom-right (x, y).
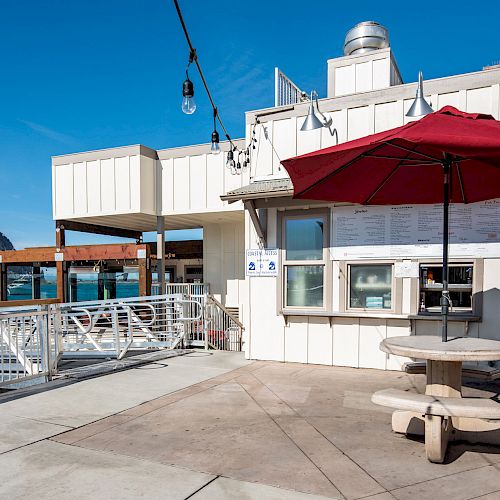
top-left (0, 0), bottom-right (500, 248)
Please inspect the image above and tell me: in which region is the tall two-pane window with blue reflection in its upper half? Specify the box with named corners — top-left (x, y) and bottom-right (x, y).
top-left (282, 213), bottom-right (328, 309)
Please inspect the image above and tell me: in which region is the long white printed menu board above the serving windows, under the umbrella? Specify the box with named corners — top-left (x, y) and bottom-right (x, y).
top-left (331, 199), bottom-right (500, 260)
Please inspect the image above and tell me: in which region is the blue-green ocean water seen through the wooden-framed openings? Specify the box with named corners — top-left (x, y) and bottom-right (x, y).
top-left (8, 280), bottom-right (139, 302)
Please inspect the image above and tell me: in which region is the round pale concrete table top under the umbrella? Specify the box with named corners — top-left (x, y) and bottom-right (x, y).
top-left (380, 335), bottom-right (500, 361)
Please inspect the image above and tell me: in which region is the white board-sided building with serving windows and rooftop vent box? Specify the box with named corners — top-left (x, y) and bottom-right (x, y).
top-left (52, 22), bottom-right (500, 369)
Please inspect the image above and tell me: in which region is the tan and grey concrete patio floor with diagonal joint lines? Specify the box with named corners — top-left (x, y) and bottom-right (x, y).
top-left (0, 352), bottom-right (500, 500)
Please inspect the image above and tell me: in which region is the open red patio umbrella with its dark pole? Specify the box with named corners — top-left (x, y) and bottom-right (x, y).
top-left (282, 106), bottom-right (500, 341)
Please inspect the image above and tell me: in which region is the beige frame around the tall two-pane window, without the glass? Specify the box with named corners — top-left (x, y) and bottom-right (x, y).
top-left (278, 208), bottom-right (332, 314)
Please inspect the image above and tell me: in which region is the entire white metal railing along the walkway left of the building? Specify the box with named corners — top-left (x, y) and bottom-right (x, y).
top-left (0, 283), bottom-right (244, 389)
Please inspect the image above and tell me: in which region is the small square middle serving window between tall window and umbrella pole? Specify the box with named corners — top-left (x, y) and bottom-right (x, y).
top-left (348, 264), bottom-right (393, 310)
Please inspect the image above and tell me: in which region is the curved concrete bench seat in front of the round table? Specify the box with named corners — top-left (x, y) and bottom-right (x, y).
top-left (372, 389), bottom-right (500, 420)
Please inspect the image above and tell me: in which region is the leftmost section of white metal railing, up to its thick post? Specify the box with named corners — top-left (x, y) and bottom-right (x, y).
top-left (0, 306), bottom-right (56, 388)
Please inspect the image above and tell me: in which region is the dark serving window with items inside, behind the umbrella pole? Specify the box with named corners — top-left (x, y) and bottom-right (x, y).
top-left (419, 262), bottom-right (474, 313)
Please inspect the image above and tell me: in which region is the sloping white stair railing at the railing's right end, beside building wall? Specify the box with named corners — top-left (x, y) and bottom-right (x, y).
top-left (204, 295), bottom-right (244, 351)
